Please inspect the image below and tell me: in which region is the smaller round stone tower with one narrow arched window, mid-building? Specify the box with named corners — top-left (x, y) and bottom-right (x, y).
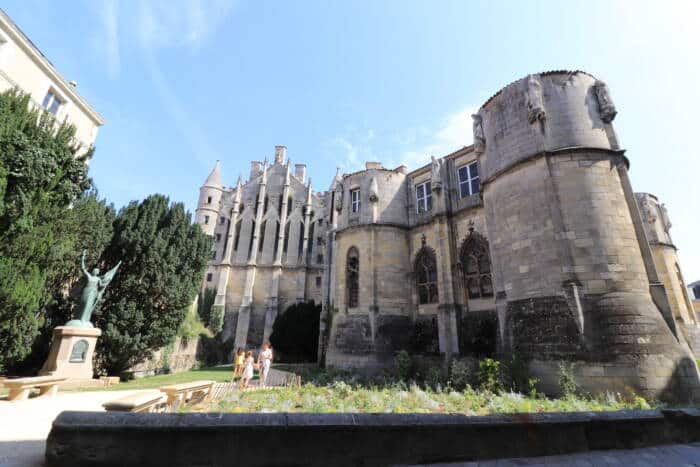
top-left (326, 162), bottom-right (413, 373)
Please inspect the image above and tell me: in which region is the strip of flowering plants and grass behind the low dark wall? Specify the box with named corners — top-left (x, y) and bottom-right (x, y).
top-left (193, 382), bottom-right (650, 415)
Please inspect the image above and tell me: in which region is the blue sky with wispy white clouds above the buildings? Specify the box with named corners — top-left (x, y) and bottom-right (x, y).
top-left (2, 0), bottom-right (700, 281)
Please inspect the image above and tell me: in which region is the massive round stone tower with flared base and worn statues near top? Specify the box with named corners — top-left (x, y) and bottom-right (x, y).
top-left (474, 71), bottom-right (700, 399)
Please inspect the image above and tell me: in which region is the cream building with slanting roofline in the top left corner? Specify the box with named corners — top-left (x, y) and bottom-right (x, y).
top-left (0, 9), bottom-right (104, 150)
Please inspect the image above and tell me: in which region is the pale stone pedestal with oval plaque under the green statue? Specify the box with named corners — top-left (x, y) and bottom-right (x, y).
top-left (39, 326), bottom-right (102, 379)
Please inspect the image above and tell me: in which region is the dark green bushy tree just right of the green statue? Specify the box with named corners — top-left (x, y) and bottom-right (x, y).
top-left (94, 195), bottom-right (212, 374)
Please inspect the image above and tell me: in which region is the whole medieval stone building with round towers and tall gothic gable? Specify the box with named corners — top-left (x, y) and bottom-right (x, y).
top-left (197, 71), bottom-right (700, 399)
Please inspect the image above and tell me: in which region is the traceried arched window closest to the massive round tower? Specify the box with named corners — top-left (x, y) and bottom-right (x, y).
top-left (460, 230), bottom-right (493, 298)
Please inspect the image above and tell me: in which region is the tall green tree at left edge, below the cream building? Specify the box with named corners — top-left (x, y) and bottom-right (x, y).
top-left (0, 90), bottom-right (93, 371)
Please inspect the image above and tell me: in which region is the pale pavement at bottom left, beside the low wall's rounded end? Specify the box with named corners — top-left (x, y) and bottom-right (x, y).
top-left (0, 390), bottom-right (139, 467)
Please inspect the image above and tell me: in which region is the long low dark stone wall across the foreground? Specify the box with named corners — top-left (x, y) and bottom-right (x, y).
top-left (46, 409), bottom-right (700, 467)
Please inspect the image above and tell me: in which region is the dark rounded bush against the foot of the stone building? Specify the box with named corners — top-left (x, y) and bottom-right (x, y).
top-left (270, 301), bottom-right (321, 362)
